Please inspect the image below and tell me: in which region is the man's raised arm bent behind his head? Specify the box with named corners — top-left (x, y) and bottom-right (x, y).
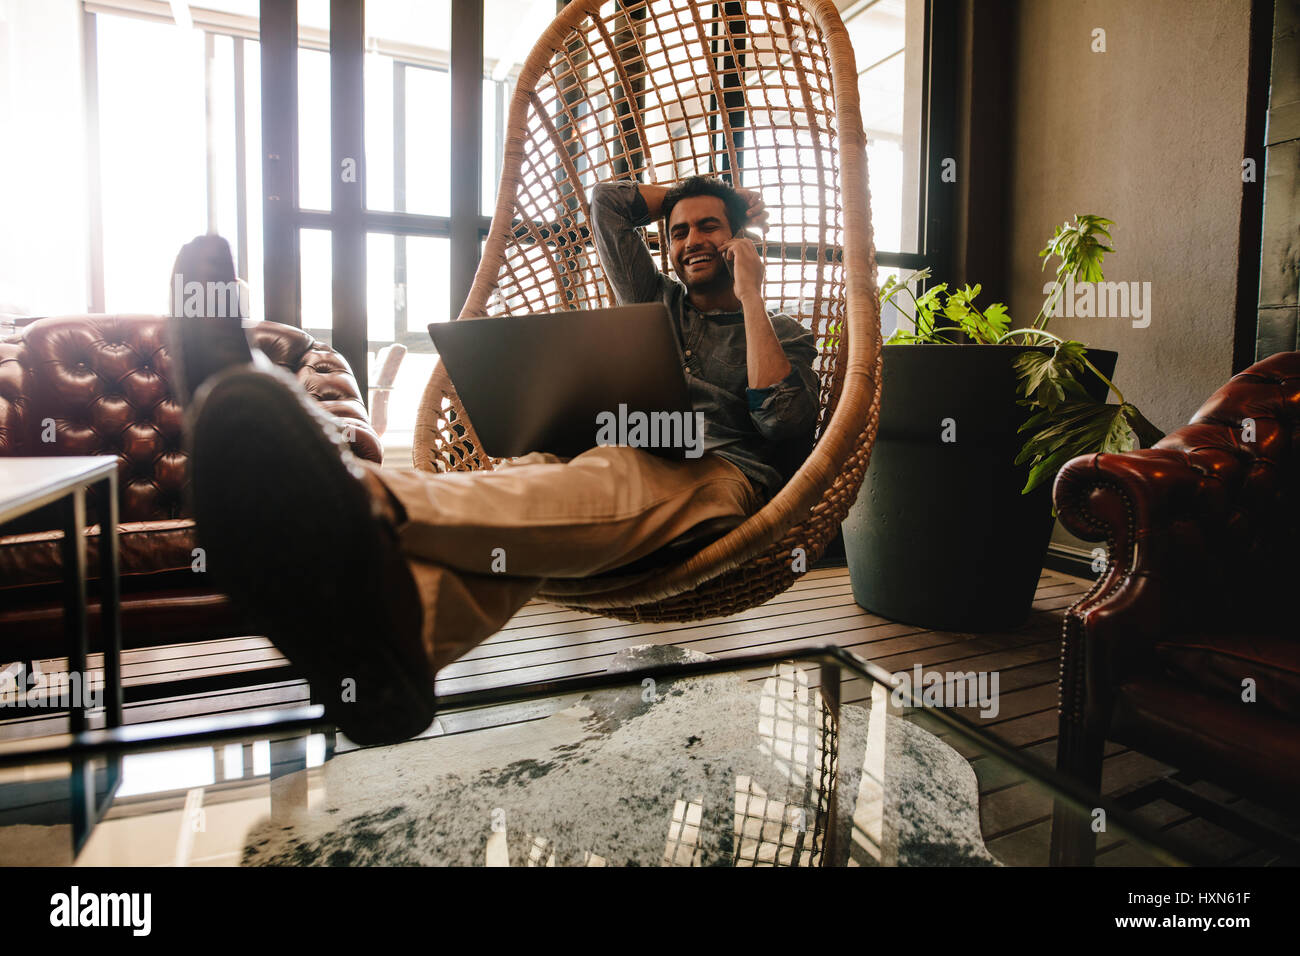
top-left (592, 181), bottom-right (668, 306)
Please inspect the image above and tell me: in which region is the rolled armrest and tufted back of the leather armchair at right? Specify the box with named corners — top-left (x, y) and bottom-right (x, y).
top-left (1053, 352), bottom-right (1300, 698)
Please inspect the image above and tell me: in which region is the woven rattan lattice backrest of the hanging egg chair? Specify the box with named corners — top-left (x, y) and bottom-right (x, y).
top-left (462, 0), bottom-right (866, 432)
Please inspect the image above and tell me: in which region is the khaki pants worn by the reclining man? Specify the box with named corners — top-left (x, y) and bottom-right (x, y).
top-left (363, 446), bottom-right (759, 669)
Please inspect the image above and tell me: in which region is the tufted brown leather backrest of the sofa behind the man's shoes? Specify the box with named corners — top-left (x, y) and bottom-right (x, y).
top-left (0, 315), bottom-right (382, 522)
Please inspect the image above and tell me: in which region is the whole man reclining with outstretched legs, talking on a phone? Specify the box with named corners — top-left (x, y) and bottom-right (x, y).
top-left (174, 178), bottom-right (818, 743)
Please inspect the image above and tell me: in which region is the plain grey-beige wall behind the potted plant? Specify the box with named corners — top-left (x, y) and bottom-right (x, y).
top-left (1006, 0), bottom-right (1249, 431)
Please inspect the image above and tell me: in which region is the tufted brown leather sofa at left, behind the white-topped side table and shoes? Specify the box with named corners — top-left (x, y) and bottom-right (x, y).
top-left (0, 315), bottom-right (382, 662)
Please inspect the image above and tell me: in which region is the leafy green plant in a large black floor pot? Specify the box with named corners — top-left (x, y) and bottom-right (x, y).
top-left (844, 216), bottom-right (1161, 631)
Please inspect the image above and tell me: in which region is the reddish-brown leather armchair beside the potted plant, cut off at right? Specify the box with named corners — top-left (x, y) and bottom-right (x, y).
top-left (1053, 352), bottom-right (1300, 862)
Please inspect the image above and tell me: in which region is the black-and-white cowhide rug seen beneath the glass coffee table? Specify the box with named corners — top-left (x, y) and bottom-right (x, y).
top-left (243, 645), bottom-right (996, 866)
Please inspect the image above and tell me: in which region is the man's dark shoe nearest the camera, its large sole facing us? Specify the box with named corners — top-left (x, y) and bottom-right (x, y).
top-left (189, 368), bottom-right (434, 744)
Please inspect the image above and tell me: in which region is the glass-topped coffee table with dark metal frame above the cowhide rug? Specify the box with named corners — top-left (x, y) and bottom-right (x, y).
top-left (0, 646), bottom-right (1188, 866)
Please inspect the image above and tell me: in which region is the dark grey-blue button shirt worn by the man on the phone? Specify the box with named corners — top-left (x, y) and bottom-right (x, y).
top-left (592, 181), bottom-right (819, 502)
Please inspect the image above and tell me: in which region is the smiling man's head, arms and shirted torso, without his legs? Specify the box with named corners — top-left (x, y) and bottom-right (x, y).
top-left (592, 176), bottom-right (818, 501)
